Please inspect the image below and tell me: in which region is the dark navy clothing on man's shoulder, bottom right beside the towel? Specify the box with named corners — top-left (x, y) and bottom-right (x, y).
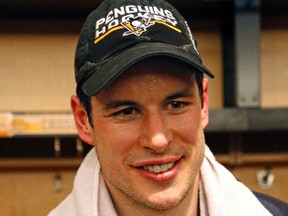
top-left (253, 192), bottom-right (288, 216)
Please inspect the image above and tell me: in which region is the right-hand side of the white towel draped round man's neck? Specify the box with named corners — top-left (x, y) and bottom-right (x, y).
top-left (199, 146), bottom-right (271, 216)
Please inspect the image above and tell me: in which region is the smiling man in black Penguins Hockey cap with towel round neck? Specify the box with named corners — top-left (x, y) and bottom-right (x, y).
top-left (50, 0), bottom-right (287, 216)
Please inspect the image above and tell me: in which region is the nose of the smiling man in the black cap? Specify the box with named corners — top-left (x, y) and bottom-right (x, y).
top-left (140, 113), bottom-right (173, 153)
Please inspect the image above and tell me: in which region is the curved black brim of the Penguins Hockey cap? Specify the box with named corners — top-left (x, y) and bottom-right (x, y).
top-left (82, 42), bottom-right (214, 96)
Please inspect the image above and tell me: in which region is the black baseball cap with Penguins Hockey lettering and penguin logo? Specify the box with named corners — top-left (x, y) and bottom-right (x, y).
top-left (75, 0), bottom-right (214, 96)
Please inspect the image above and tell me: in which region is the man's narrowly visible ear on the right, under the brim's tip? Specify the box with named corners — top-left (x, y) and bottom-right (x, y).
top-left (201, 77), bottom-right (209, 128)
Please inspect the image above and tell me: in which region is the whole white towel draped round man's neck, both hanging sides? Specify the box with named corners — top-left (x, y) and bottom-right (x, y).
top-left (49, 147), bottom-right (271, 216)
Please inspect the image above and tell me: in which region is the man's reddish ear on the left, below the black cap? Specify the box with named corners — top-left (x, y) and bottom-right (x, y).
top-left (70, 95), bottom-right (93, 145)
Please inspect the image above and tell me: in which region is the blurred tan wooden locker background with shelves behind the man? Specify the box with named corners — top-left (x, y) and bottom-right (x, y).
top-left (0, 0), bottom-right (288, 216)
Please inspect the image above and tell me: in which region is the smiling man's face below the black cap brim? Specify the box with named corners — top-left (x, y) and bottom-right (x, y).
top-left (72, 58), bottom-right (208, 213)
